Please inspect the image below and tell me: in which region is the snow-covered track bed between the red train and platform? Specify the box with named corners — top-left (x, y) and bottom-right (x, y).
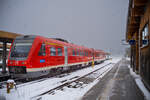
top-left (0, 58), bottom-right (120, 100)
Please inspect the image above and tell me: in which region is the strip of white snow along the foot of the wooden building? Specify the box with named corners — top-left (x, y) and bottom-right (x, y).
top-left (128, 65), bottom-right (150, 100)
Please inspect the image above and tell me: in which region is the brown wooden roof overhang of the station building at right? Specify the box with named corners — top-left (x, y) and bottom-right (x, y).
top-left (126, 0), bottom-right (148, 41)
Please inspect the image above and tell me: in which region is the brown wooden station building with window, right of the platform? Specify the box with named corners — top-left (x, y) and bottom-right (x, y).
top-left (126, 0), bottom-right (150, 90)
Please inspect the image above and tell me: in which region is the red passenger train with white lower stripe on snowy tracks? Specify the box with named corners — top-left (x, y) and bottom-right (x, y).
top-left (7, 35), bottom-right (106, 77)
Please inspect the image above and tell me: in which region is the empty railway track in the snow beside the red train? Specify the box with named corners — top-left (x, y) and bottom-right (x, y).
top-left (31, 63), bottom-right (114, 100)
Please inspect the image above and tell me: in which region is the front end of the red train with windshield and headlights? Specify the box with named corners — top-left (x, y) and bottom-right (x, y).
top-left (7, 36), bottom-right (35, 75)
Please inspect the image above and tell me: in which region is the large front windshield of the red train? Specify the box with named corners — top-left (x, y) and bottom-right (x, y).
top-left (10, 43), bottom-right (32, 58)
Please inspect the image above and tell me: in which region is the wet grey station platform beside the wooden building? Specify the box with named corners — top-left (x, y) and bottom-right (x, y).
top-left (82, 59), bottom-right (144, 100)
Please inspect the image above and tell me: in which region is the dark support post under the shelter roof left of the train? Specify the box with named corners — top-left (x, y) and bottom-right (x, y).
top-left (2, 42), bottom-right (7, 74)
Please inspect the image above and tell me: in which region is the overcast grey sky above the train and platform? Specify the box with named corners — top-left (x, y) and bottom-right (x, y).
top-left (0, 0), bottom-right (128, 54)
